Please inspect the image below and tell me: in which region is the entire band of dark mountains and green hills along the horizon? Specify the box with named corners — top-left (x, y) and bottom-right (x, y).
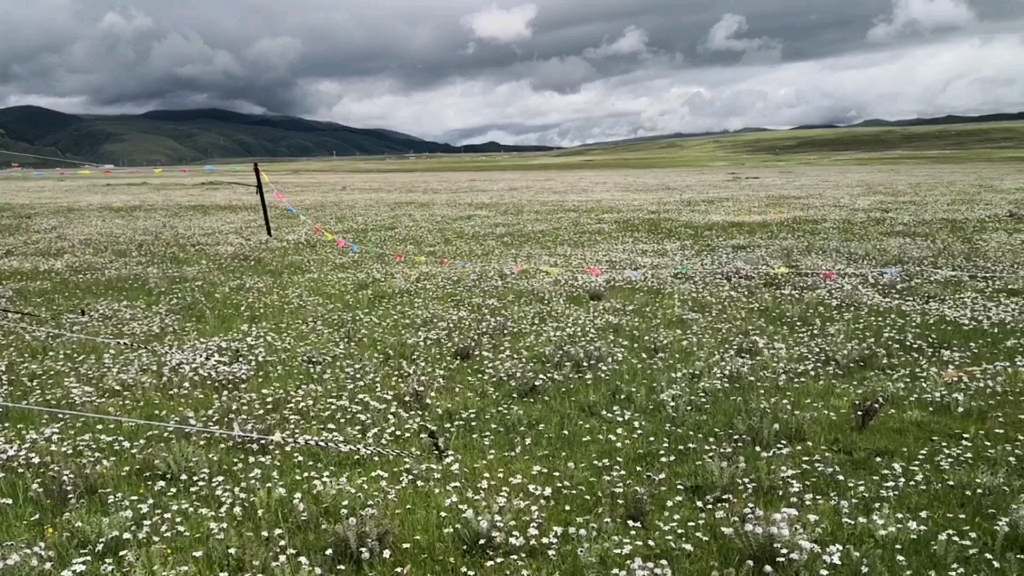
top-left (0, 107), bottom-right (1024, 170)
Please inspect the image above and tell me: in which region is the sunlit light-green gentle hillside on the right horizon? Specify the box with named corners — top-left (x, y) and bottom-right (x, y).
top-left (266, 122), bottom-right (1024, 171)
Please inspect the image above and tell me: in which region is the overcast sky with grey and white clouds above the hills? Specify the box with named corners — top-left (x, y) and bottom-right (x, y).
top-left (0, 0), bottom-right (1024, 146)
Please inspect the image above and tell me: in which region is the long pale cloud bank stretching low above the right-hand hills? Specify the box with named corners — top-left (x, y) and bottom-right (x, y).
top-left (313, 33), bottom-right (1024, 146)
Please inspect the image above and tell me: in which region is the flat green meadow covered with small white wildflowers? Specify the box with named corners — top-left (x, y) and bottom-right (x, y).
top-left (0, 152), bottom-right (1024, 576)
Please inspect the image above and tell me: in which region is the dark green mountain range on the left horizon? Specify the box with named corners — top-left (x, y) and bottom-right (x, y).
top-left (0, 106), bottom-right (557, 167)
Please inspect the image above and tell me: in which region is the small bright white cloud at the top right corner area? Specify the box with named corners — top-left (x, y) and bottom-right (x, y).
top-left (867, 0), bottom-right (978, 42)
